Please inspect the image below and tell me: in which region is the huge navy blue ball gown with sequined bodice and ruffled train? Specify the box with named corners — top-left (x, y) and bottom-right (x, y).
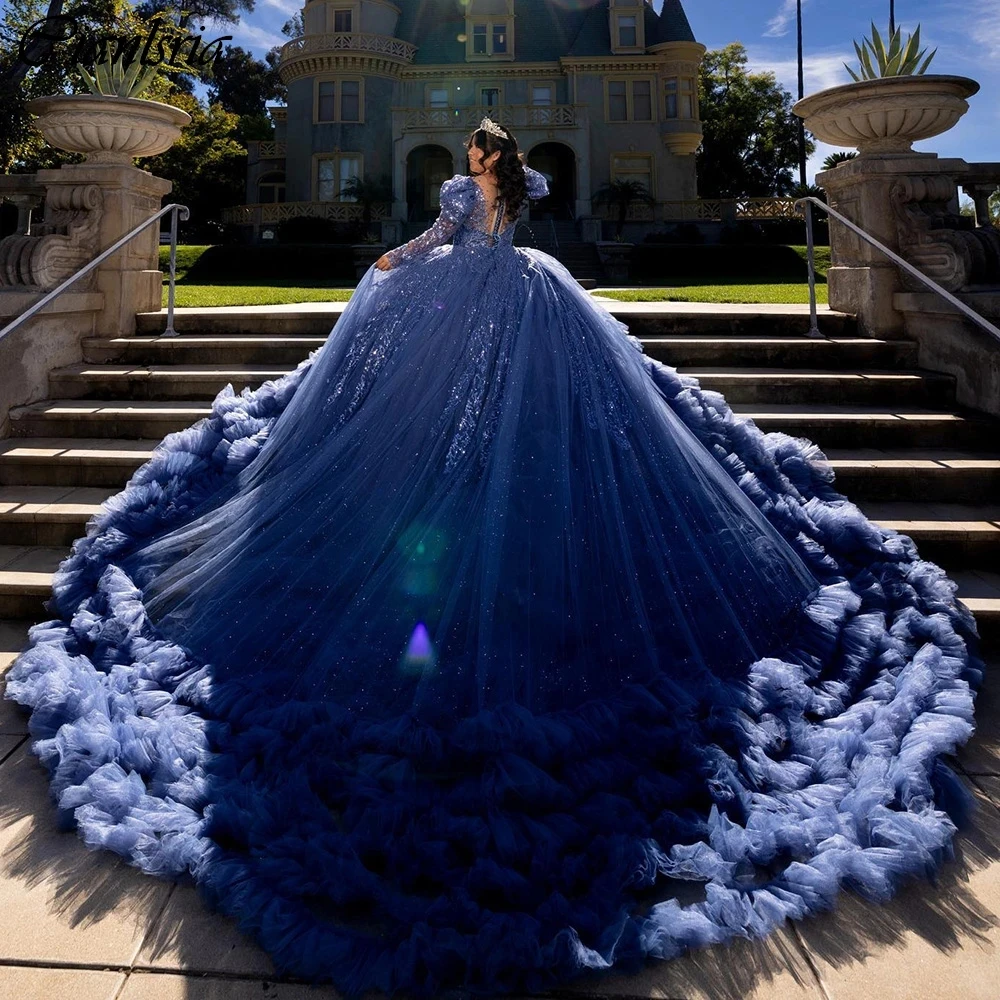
top-left (1, 170), bottom-right (980, 994)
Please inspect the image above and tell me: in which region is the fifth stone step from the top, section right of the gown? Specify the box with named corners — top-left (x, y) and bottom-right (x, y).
top-left (826, 448), bottom-right (1000, 504)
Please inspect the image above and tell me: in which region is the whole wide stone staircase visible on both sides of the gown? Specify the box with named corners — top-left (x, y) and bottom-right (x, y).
top-left (0, 303), bottom-right (1000, 648)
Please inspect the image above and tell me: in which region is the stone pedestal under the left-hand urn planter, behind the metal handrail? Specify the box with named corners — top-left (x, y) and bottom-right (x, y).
top-left (36, 163), bottom-right (173, 337)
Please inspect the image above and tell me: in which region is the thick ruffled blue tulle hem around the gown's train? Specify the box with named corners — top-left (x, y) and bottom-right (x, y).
top-left (7, 308), bottom-right (980, 994)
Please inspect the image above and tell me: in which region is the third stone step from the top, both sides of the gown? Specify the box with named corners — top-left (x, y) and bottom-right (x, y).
top-left (49, 363), bottom-right (955, 406)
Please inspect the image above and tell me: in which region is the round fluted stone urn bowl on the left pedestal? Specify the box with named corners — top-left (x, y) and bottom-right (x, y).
top-left (26, 94), bottom-right (191, 165)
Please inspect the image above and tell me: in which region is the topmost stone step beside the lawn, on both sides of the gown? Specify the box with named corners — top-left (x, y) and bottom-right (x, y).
top-left (136, 299), bottom-right (857, 337)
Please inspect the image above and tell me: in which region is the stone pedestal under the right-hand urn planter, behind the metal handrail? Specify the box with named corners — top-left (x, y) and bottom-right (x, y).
top-left (816, 153), bottom-right (968, 338)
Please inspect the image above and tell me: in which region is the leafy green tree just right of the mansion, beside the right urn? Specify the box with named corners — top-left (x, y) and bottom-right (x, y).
top-left (697, 42), bottom-right (816, 198)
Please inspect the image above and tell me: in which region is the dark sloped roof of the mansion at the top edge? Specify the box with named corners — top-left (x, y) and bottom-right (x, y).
top-left (396, 0), bottom-right (694, 65)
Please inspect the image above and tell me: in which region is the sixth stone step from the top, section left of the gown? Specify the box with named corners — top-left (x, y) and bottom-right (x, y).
top-left (0, 486), bottom-right (113, 546)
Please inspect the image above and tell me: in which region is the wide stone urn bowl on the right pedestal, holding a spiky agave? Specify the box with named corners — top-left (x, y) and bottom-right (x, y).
top-left (792, 74), bottom-right (979, 156)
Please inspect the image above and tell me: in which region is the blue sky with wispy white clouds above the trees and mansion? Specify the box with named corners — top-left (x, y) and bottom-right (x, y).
top-left (210, 0), bottom-right (1000, 183)
